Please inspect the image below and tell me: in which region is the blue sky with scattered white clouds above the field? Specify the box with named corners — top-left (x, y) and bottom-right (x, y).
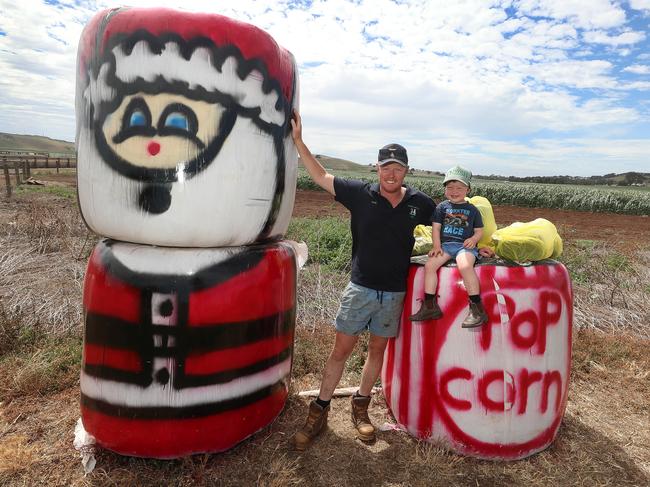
top-left (0, 0), bottom-right (650, 176)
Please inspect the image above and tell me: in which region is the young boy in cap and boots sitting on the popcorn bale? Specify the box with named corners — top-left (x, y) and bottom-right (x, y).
top-left (409, 166), bottom-right (488, 328)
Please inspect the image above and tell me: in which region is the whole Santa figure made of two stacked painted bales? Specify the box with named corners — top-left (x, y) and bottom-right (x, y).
top-left (76, 7), bottom-right (304, 458)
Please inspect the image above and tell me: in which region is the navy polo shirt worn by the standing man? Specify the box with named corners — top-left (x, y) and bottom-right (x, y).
top-left (334, 177), bottom-right (436, 292)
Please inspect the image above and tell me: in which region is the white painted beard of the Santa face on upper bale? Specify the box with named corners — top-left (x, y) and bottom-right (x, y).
top-left (78, 117), bottom-right (297, 247)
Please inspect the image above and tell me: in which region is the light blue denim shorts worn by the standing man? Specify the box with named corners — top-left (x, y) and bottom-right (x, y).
top-left (336, 282), bottom-right (406, 338)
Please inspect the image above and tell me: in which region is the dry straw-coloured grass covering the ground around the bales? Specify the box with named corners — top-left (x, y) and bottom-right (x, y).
top-left (0, 189), bottom-right (650, 487)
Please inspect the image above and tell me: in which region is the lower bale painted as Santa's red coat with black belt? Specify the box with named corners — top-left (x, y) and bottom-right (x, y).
top-left (81, 240), bottom-right (296, 458)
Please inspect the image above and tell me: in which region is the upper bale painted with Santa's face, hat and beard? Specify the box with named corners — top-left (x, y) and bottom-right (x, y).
top-left (76, 8), bottom-right (297, 247)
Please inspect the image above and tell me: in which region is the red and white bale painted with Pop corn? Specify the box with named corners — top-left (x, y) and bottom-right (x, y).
top-left (382, 261), bottom-right (573, 460)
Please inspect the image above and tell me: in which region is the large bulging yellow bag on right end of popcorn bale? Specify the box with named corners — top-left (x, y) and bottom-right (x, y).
top-left (492, 218), bottom-right (562, 262)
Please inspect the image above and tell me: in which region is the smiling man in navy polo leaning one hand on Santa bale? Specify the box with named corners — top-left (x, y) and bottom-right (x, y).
top-left (291, 112), bottom-right (436, 451)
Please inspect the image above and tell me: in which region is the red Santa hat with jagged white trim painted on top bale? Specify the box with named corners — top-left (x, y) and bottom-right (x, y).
top-left (78, 8), bottom-right (295, 125)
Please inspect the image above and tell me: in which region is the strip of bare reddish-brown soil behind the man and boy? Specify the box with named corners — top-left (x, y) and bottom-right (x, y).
top-left (293, 190), bottom-right (650, 248)
